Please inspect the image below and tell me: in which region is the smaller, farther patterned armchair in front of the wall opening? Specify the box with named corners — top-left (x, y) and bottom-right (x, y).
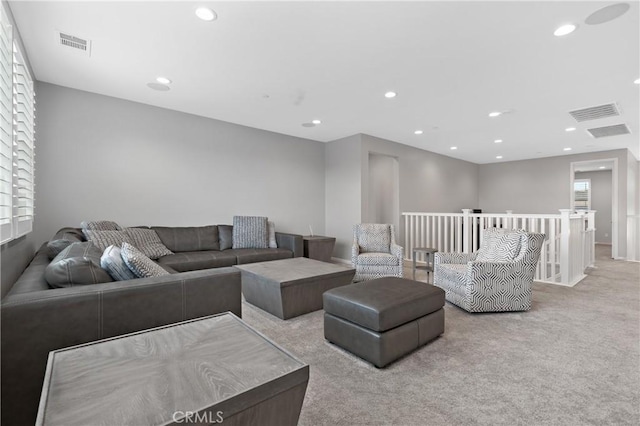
top-left (351, 223), bottom-right (404, 281)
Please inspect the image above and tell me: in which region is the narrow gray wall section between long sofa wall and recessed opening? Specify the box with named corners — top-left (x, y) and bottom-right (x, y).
top-left (324, 135), bottom-right (362, 259)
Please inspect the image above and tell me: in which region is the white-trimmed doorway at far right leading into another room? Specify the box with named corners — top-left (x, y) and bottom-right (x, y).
top-left (571, 158), bottom-right (618, 259)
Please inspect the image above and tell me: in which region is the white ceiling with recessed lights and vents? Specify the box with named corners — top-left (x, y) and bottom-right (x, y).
top-left (10, 1), bottom-right (640, 163)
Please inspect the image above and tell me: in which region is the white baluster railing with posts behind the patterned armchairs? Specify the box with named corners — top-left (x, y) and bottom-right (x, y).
top-left (402, 209), bottom-right (595, 286)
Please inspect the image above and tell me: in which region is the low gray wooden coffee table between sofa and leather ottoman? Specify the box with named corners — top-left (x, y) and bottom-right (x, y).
top-left (236, 257), bottom-right (355, 319)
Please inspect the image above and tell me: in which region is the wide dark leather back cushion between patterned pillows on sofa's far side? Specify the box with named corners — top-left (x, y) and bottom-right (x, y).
top-left (151, 225), bottom-right (220, 252)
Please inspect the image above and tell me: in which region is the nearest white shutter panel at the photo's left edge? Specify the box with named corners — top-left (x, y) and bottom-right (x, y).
top-left (0, 7), bottom-right (13, 243)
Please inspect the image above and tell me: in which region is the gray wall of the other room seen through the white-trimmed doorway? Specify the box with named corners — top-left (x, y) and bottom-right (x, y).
top-left (575, 170), bottom-right (612, 244)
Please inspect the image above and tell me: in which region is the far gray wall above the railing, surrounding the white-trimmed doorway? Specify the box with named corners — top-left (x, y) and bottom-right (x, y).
top-left (478, 149), bottom-right (630, 258)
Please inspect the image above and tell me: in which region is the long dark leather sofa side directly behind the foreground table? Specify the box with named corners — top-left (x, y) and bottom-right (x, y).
top-left (0, 267), bottom-right (241, 424)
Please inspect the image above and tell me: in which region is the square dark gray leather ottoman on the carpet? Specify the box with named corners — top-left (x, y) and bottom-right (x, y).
top-left (323, 277), bottom-right (444, 368)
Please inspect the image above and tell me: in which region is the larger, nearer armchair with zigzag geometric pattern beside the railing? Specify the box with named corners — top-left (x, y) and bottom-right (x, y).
top-left (433, 228), bottom-right (545, 312)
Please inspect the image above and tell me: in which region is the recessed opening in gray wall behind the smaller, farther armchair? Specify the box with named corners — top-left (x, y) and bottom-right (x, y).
top-left (367, 152), bottom-right (400, 233)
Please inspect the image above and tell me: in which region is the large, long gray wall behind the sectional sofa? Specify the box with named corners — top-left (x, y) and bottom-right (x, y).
top-left (34, 83), bottom-right (325, 246)
